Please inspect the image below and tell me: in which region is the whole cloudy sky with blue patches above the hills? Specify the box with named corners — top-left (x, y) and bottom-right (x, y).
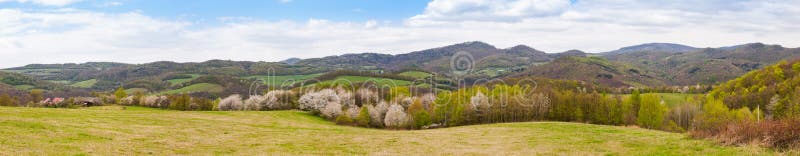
top-left (0, 0), bottom-right (800, 68)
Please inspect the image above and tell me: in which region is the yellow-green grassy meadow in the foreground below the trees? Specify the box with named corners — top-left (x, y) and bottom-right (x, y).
top-left (0, 106), bottom-right (770, 155)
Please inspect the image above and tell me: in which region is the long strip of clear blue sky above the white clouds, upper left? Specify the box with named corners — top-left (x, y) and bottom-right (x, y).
top-left (0, 0), bottom-right (428, 22)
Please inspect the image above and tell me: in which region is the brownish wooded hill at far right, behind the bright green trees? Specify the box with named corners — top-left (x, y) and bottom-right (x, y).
top-left (602, 43), bottom-right (800, 85)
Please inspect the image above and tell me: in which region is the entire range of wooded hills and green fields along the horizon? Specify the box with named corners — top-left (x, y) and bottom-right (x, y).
top-left (0, 41), bottom-right (800, 95)
